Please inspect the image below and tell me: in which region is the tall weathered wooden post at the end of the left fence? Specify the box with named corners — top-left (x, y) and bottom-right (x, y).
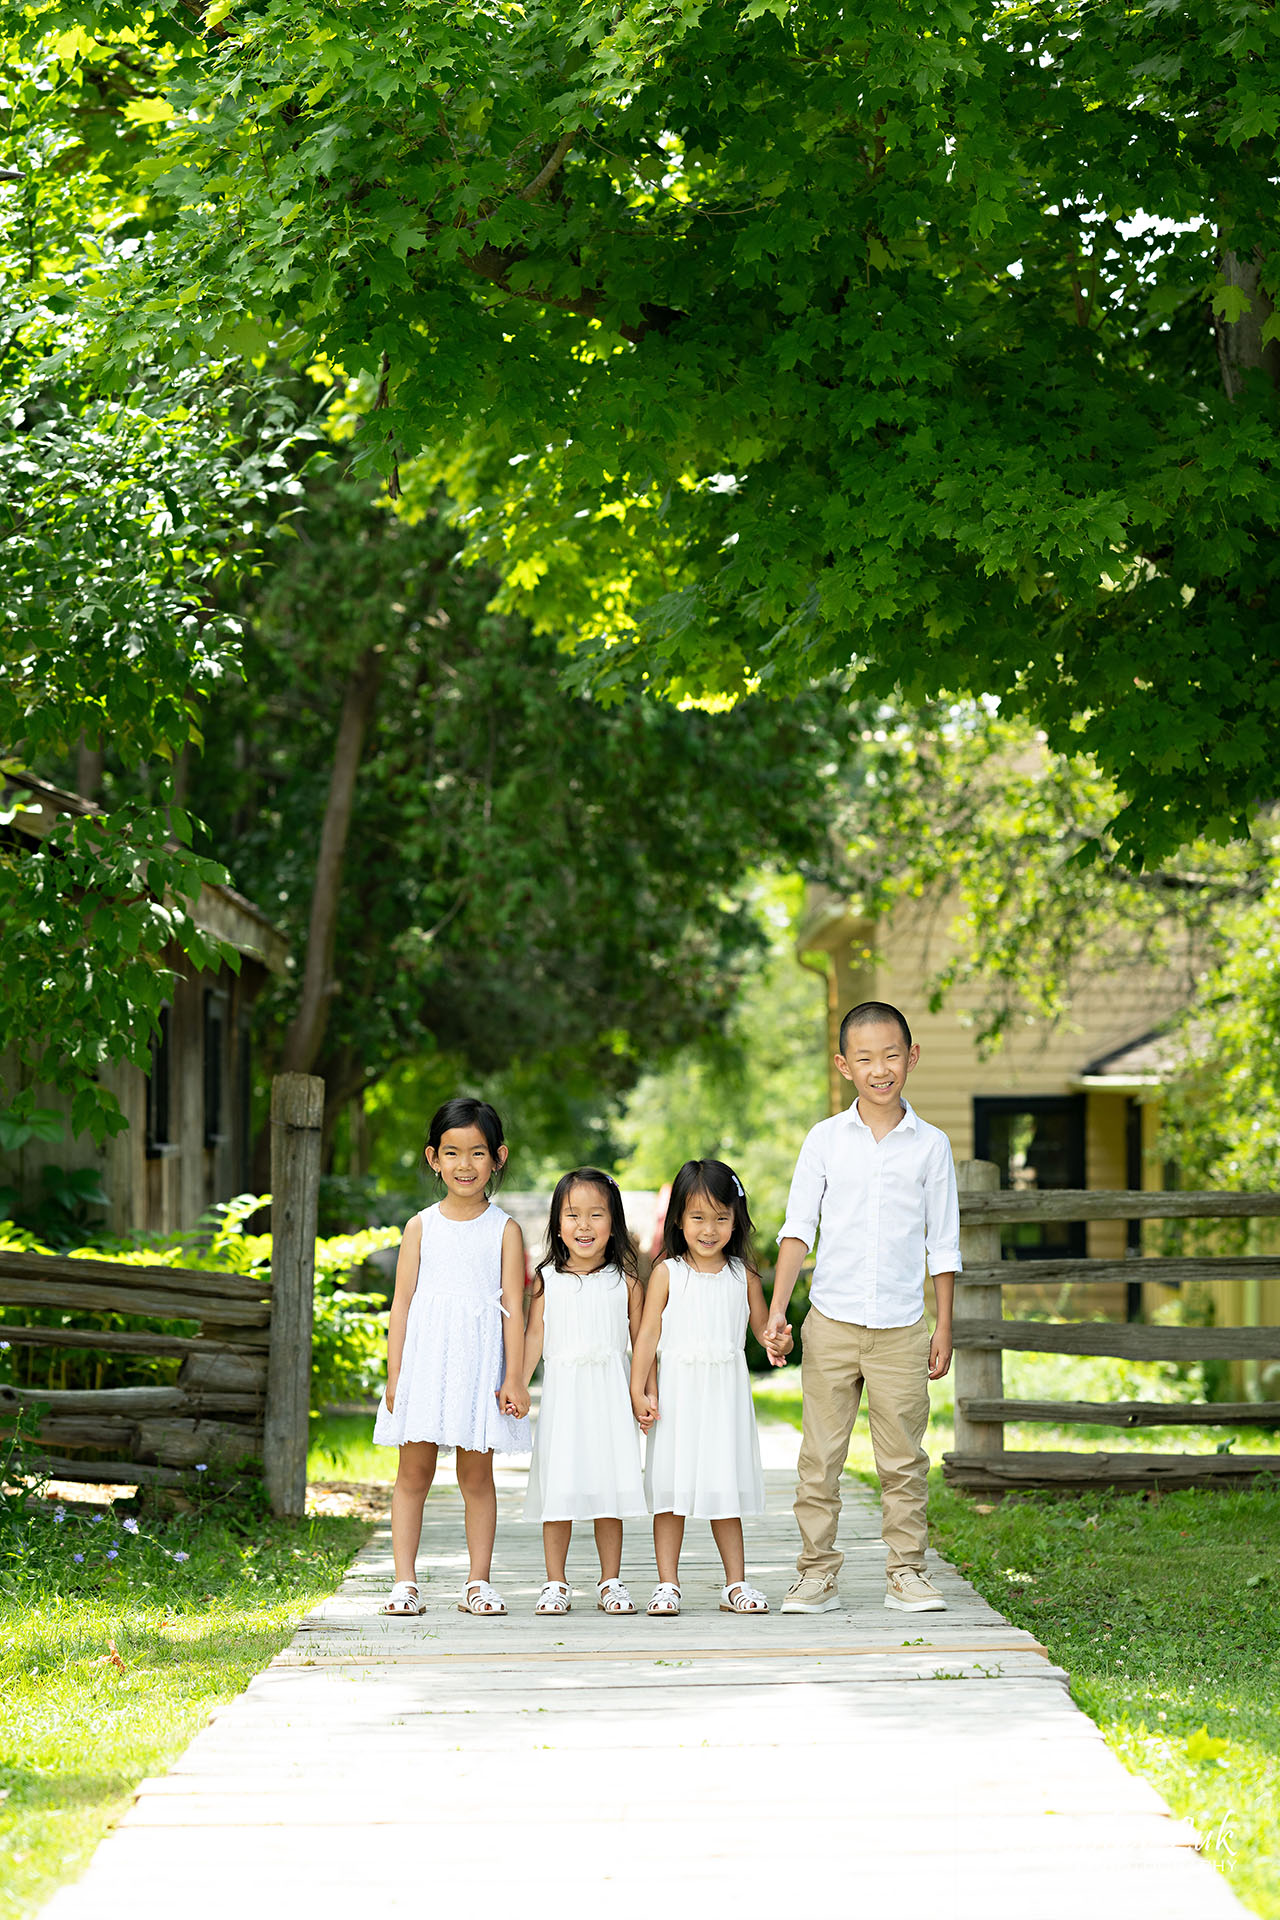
top-left (263, 1073), bottom-right (324, 1519)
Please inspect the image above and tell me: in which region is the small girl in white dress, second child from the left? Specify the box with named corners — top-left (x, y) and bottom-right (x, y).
top-left (524, 1167), bottom-right (649, 1613)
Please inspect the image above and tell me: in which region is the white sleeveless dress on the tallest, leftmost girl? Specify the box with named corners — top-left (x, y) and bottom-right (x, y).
top-left (374, 1204), bottom-right (530, 1453)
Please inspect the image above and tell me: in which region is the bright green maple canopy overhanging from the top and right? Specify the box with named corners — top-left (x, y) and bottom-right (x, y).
top-left (52, 0), bottom-right (1280, 858)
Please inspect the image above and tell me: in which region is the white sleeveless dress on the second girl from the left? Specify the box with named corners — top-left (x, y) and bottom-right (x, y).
top-left (524, 1267), bottom-right (649, 1521)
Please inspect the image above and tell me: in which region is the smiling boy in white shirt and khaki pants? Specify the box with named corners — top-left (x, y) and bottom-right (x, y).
top-left (770, 1000), bottom-right (960, 1613)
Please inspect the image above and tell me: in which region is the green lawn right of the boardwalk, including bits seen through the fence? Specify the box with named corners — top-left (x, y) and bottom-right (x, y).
top-left (756, 1354), bottom-right (1280, 1920)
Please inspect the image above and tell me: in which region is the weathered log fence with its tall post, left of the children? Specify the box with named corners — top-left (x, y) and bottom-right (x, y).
top-left (0, 1073), bottom-right (324, 1515)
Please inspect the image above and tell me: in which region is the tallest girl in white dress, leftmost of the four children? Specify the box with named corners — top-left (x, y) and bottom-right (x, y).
top-left (374, 1098), bottom-right (530, 1615)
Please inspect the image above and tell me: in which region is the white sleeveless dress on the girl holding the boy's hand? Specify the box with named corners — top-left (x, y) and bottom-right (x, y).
top-left (645, 1260), bottom-right (764, 1521)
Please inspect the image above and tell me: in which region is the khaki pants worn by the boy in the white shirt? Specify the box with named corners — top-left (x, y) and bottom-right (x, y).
top-left (796, 1308), bottom-right (929, 1578)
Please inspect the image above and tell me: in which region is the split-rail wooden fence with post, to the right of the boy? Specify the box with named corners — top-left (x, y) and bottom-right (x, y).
top-left (942, 1160), bottom-right (1280, 1492)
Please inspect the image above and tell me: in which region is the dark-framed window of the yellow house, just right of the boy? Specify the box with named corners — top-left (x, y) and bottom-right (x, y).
top-left (973, 1092), bottom-right (1084, 1260)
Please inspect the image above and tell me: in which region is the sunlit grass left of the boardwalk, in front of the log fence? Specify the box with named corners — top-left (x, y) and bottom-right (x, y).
top-left (0, 1505), bottom-right (368, 1920)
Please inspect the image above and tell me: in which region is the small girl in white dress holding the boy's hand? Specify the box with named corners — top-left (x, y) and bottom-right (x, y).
top-left (631, 1160), bottom-right (791, 1615)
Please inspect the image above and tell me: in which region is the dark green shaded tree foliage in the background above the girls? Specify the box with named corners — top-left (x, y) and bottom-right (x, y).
top-left (190, 470), bottom-right (862, 1159)
